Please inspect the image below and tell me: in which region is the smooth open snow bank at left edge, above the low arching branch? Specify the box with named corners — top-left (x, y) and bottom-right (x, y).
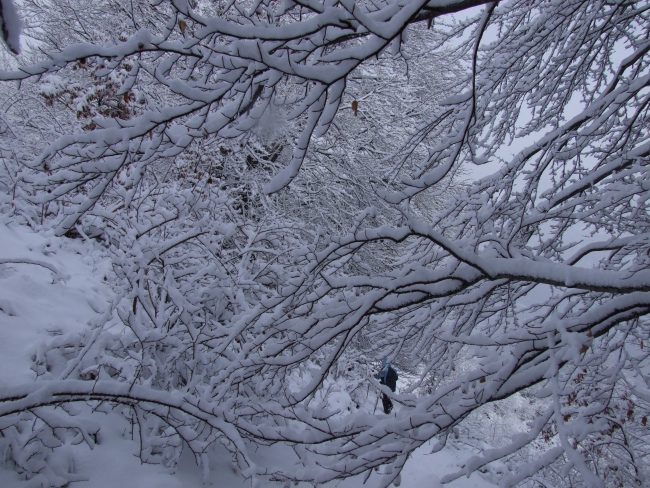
top-left (0, 222), bottom-right (110, 389)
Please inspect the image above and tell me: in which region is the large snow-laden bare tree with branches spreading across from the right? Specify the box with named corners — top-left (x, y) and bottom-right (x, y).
top-left (0, 0), bottom-right (650, 486)
